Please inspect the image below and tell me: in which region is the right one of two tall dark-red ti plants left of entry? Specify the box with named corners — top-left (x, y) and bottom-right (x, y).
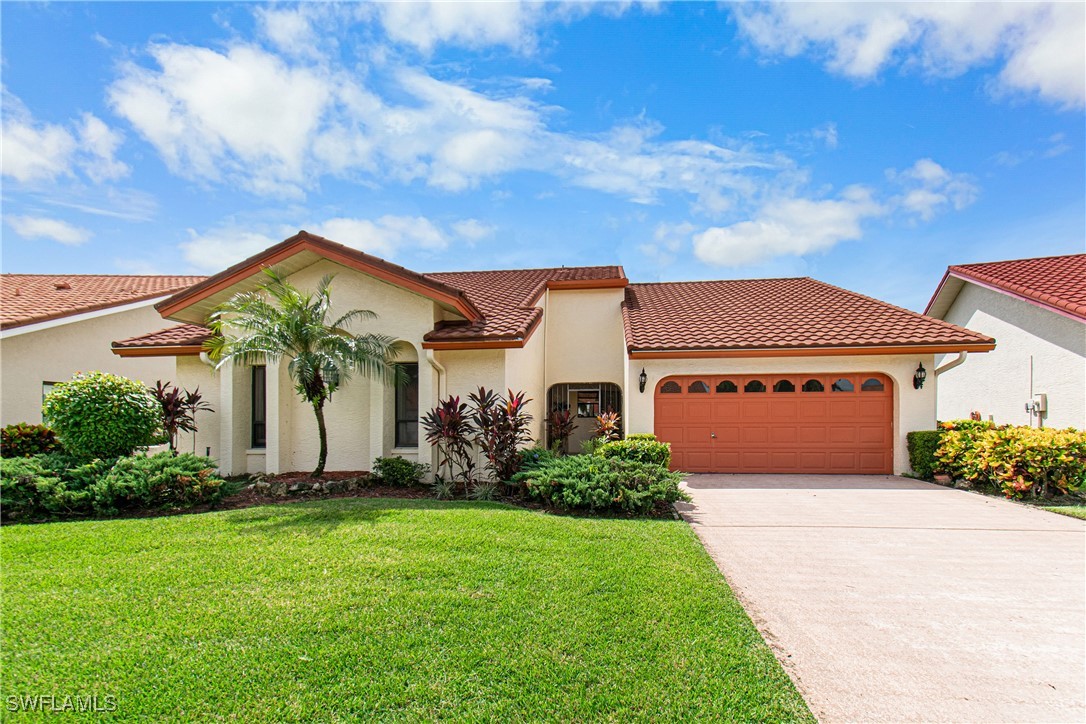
top-left (468, 388), bottom-right (532, 482)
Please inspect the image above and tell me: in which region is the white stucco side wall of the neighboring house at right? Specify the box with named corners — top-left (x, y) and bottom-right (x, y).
top-left (938, 282), bottom-right (1086, 430)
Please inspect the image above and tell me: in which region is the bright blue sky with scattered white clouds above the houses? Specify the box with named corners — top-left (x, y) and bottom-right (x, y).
top-left (0, 2), bottom-right (1086, 308)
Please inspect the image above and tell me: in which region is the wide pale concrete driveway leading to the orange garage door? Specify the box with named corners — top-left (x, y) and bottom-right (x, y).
top-left (680, 475), bottom-right (1086, 722)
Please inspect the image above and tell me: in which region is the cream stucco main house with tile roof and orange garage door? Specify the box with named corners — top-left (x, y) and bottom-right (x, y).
top-left (114, 231), bottom-right (994, 473)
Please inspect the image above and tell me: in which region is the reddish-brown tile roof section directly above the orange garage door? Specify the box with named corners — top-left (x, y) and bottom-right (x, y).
top-left (622, 278), bottom-right (993, 351)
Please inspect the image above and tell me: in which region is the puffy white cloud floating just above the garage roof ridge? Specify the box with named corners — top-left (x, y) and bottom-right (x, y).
top-left (694, 186), bottom-right (886, 267)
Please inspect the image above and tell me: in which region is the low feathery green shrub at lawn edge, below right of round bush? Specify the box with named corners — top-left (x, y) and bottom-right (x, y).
top-left (88, 453), bottom-right (224, 516)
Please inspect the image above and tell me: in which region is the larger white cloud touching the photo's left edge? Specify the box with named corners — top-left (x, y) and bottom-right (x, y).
top-left (2, 90), bottom-right (129, 183)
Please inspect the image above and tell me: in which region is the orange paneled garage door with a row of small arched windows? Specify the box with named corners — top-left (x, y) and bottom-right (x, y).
top-left (656, 373), bottom-right (894, 473)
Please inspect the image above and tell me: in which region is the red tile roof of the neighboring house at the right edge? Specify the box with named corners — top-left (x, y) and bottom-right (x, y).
top-left (927, 254), bottom-right (1086, 319)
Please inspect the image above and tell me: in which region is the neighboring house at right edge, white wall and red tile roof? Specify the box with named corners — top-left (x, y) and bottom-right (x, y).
top-left (925, 254), bottom-right (1086, 430)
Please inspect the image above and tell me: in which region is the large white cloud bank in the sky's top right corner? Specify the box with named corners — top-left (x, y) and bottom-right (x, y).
top-left (734, 2), bottom-right (1086, 107)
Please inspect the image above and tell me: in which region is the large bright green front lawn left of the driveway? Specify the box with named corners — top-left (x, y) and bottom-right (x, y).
top-left (0, 499), bottom-right (812, 721)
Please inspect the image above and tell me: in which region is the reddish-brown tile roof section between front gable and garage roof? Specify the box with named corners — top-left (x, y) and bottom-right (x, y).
top-left (426, 266), bottom-right (627, 342)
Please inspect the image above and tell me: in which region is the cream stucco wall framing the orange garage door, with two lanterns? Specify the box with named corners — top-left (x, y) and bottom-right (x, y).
top-left (627, 355), bottom-right (936, 472)
